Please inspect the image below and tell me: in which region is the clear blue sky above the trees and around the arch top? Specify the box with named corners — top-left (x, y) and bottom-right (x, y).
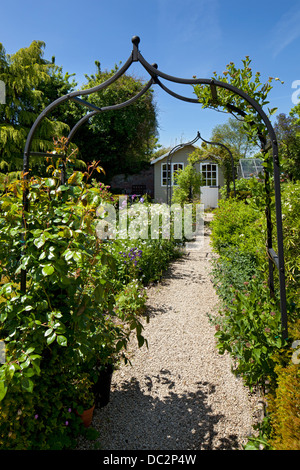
top-left (0, 0), bottom-right (300, 146)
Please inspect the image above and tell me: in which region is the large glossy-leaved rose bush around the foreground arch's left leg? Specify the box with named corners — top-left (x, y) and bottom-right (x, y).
top-left (0, 172), bottom-right (139, 448)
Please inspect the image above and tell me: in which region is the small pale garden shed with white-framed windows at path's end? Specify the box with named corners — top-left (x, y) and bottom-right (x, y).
top-left (151, 145), bottom-right (225, 209)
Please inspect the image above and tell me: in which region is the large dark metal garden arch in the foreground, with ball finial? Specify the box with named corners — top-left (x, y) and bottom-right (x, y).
top-left (21, 36), bottom-right (288, 339)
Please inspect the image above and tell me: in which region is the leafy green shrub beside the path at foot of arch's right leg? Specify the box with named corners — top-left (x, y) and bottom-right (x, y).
top-left (215, 277), bottom-right (284, 387)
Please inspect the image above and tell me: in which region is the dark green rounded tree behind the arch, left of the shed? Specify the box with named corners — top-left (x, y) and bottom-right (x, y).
top-left (74, 61), bottom-right (157, 178)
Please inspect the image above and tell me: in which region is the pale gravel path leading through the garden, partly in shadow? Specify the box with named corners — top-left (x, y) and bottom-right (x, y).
top-left (80, 218), bottom-right (256, 451)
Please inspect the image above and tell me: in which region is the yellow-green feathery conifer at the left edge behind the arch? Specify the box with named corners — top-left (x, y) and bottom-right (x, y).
top-left (0, 41), bottom-right (73, 173)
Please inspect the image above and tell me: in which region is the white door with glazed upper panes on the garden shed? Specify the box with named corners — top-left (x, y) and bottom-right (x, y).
top-left (201, 163), bottom-right (219, 209)
